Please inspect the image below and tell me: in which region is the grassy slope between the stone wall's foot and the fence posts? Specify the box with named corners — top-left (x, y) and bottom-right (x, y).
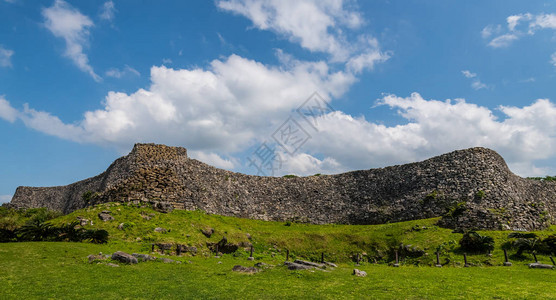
top-left (25, 203), bottom-right (556, 266)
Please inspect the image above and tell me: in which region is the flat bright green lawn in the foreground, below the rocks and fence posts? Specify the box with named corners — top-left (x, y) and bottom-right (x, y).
top-left (0, 242), bottom-right (556, 299)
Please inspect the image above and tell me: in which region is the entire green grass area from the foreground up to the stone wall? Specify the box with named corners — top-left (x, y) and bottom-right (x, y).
top-left (0, 204), bottom-right (556, 299)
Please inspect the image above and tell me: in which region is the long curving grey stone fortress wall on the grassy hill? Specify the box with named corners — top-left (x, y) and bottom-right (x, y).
top-left (11, 144), bottom-right (556, 230)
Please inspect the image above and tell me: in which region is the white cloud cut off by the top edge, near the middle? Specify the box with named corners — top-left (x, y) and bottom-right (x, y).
top-left (217, 0), bottom-right (390, 69)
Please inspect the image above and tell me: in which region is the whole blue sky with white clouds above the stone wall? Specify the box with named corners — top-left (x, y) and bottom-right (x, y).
top-left (0, 0), bottom-right (556, 202)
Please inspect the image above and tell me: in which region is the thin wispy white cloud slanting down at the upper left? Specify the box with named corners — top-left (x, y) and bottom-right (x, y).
top-left (42, 0), bottom-right (102, 82)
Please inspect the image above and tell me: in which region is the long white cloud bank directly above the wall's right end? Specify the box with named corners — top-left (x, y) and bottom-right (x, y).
top-left (296, 93), bottom-right (556, 175)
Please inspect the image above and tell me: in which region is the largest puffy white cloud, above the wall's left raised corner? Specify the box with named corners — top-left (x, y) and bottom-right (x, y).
top-left (1, 55), bottom-right (355, 157)
